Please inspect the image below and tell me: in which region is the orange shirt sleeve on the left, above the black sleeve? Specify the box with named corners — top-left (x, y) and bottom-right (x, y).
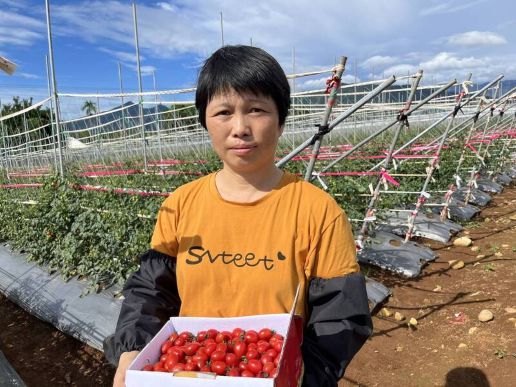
top-left (151, 194), bottom-right (180, 257)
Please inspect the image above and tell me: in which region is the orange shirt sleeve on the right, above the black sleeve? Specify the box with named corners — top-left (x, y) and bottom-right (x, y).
top-left (308, 211), bottom-right (360, 278)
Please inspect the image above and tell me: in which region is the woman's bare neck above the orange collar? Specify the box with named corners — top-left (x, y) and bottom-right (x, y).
top-left (215, 164), bottom-right (283, 203)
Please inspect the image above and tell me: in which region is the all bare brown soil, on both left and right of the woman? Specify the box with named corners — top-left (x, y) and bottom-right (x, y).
top-left (0, 188), bottom-right (516, 387)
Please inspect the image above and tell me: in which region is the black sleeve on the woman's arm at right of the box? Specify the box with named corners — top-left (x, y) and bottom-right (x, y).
top-left (301, 273), bottom-right (373, 387)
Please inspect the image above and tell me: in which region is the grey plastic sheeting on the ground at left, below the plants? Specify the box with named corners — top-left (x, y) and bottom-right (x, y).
top-left (0, 246), bottom-right (122, 352)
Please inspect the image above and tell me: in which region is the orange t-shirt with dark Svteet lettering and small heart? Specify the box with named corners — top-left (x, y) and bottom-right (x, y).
top-left (151, 173), bottom-right (359, 317)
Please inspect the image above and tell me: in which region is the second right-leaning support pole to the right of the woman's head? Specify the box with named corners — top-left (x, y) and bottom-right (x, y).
top-left (357, 70), bottom-right (423, 247)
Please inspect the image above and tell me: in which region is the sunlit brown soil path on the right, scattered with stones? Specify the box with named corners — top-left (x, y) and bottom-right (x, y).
top-left (339, 188), bottom-right (516, 387)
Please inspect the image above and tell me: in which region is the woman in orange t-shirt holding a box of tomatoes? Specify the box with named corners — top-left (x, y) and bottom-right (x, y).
top-left (111, 46), bottom-right (372, 387)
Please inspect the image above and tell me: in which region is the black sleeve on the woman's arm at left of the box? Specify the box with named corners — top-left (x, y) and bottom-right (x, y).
top-left (104, 249), bottom-right (181, 366)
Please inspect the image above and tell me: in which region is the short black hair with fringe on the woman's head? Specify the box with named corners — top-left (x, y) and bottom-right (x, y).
top-left (195, 45), bottom-right (290, 128)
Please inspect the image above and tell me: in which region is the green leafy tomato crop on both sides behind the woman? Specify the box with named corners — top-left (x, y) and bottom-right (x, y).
top-left (0, 127), bottom-right (508, 290)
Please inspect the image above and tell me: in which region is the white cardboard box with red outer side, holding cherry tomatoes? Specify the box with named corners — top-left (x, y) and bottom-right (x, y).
top-left (125, 313), bottom-right (303, 387)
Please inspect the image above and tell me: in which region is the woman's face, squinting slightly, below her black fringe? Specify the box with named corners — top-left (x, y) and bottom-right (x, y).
top-left (206, 90), bottom-right (283, 173)
